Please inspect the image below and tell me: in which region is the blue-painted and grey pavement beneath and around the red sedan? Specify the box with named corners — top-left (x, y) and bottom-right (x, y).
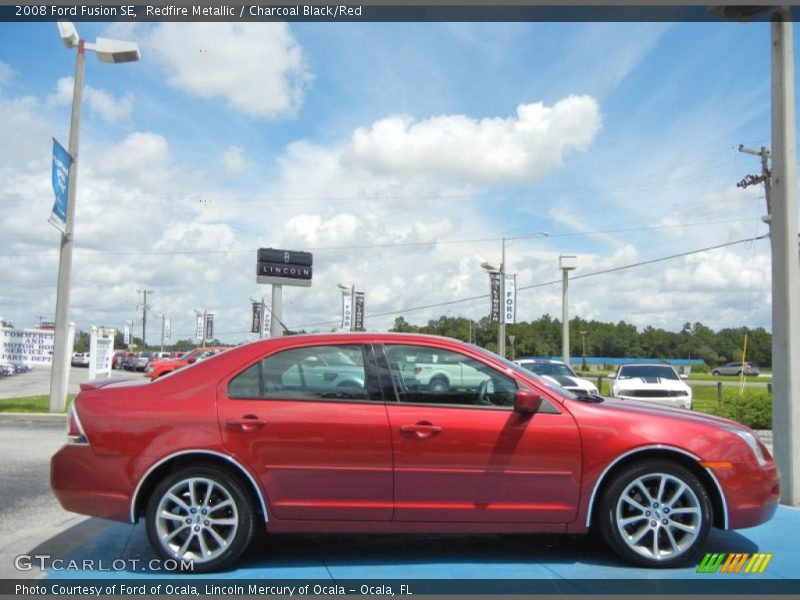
top-left (0, 418), bottom-right (800, 593)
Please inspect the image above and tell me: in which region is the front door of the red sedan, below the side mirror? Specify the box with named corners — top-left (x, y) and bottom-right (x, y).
top-left (376, 344), bottom-right (581, 523)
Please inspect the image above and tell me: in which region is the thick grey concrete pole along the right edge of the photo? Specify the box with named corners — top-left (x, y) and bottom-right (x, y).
top-left (770, 8), bottom-right (800, 506)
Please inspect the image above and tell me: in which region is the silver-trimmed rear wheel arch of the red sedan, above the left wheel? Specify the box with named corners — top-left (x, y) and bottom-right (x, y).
top-left (130, 449), bottom-right (269, 523)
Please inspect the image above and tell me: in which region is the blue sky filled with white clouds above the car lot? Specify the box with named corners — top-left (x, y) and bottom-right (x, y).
top-left (0, 23), bottom-right (792, 341)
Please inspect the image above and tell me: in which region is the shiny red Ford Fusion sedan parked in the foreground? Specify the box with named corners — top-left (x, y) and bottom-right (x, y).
top-left (51, 333), bottom-right (779, 570)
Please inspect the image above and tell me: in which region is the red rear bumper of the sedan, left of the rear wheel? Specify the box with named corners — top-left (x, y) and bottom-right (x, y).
top-left (50, 444), bottom-right (131, 523)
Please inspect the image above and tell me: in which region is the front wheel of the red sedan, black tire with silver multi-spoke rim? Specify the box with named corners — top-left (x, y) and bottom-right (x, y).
top-left (597, 459), bottom-right (713, 568)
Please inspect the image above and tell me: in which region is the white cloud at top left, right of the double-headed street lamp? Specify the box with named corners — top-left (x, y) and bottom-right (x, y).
top-left (144, 23), bottom-right (312, 119)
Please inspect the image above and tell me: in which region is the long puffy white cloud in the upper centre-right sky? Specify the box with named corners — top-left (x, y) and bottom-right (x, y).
top-left (349, 96), bottom-right (601, 184)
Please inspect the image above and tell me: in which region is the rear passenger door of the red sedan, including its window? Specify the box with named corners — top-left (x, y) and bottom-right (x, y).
top-left (217, 344), bottom-right (393, 521)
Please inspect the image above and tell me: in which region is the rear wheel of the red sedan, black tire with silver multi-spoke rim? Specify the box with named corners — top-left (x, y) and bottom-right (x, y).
top-left (145, 466), bottom-right (255, 573)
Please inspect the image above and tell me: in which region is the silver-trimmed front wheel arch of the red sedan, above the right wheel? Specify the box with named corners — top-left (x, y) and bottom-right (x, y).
top-left (586, 445), bottom-right (728, 529)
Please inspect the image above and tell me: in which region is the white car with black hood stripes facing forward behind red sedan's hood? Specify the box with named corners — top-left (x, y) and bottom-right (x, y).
top-left (610, 364), bottom-right (692, 410)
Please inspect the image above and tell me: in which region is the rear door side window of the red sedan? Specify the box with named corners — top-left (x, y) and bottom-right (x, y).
top-left (228, 345), bottom-right (378, 400)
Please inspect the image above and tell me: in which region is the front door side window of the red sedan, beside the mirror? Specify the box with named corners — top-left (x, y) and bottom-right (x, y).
top-left (384, 345), bottom-right (517, 408)
